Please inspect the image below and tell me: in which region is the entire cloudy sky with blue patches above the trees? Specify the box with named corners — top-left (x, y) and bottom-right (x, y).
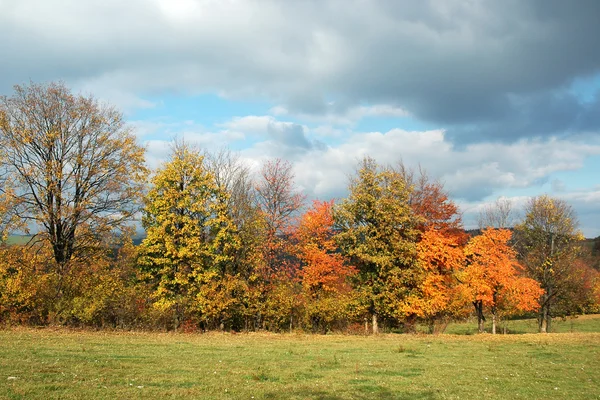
top-left (0, 0), bottom-right (600, 237)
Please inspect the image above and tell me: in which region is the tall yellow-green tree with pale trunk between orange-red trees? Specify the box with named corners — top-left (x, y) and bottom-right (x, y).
top-left (335, 158), bottom-right (418, 333)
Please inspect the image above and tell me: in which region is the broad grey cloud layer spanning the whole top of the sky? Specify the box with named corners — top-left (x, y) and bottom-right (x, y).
top-left (0, 0), bottom-right (600, 144)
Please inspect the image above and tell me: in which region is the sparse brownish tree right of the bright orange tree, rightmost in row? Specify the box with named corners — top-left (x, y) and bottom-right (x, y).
top-left (515, 195), bottom-right (583, 333)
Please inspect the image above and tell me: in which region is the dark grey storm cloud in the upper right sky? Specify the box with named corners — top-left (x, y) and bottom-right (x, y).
top-left (318, 1), bottom-right (600, 141)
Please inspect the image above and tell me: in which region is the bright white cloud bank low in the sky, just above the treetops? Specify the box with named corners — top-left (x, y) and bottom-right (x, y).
top-left (147, 112), bottom-right (600, 235)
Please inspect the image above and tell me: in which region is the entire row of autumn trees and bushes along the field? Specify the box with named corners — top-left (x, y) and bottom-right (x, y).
top-left (0, 83), bottom-right (600, 333)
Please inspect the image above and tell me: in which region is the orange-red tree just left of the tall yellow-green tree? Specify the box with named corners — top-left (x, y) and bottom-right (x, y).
top-left (294, 201), bottom-right (356, 330)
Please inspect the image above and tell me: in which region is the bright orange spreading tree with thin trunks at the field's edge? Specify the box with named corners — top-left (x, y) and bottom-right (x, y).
top-left (460, 228), bottom-right (543, 333)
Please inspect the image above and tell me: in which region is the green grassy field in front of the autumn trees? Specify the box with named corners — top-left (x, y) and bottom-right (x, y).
top-left (0, 328), bottom-right (600, 400)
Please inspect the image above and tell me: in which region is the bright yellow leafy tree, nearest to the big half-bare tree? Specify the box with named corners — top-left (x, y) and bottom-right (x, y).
top-left (139, 143), bottom-right (238, 328)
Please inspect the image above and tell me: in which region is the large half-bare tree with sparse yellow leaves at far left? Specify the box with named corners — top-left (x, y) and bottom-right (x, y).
top-left (0, 83), bottom-right (146, 268)
